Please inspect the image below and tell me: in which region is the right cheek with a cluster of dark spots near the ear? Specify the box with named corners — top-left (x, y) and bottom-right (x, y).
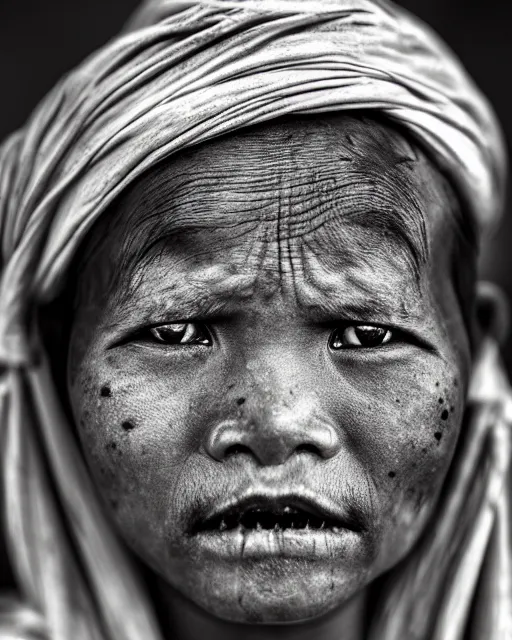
top-left (330, 362), bottom-right (466, 571)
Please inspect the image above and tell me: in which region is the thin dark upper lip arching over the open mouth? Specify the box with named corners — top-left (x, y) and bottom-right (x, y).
top-left (193, 490), bottom-right (366, 533)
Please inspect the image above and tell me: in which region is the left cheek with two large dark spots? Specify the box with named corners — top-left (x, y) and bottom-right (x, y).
top-left (70, 354), bottom-right (205, 562)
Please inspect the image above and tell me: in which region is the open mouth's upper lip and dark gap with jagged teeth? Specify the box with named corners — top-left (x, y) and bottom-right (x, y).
top-left (192, 495), bottom-right (365, 534)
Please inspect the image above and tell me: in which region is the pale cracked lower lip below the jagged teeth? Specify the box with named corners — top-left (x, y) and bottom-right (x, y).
top-left (191, 527), bottom-right (362, 561)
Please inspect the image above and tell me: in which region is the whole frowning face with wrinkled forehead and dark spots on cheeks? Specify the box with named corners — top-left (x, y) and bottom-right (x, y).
top-left (68, 117), bottom-right (469, 622)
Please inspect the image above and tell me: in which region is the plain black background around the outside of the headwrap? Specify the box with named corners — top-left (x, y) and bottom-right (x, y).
top-left (0, 0), bottom-right (512, 360)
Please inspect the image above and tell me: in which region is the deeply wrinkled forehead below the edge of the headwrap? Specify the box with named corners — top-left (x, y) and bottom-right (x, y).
top-left (83, 115), bottom-right (460, 288)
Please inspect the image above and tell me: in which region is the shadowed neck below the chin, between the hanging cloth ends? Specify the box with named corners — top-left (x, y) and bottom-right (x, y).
top-left (153, 585), bottom-right (366, 640)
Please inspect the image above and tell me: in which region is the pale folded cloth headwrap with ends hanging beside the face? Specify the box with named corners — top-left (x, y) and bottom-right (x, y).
top-left (0, 0), bottom-right (511, 640)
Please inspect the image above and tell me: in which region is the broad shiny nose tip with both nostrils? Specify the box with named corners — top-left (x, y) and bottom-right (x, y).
top-left (205, 402), bottom-right (341, 466)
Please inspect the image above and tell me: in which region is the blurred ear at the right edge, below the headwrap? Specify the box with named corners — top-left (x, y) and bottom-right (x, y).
top-left (475, 281), bottom-right (510, 348)
